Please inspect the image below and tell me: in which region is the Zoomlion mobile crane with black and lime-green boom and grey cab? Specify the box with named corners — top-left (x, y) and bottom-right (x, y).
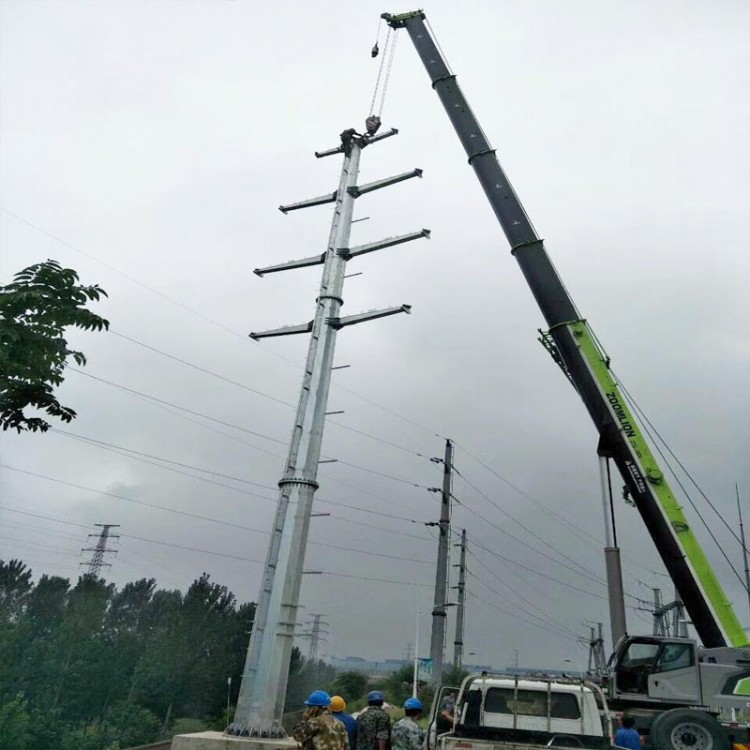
top-left (382, 10), bottom-right (750, 750)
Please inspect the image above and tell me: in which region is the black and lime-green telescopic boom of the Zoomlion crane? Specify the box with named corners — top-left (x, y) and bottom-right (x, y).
top-left (383, 11), bottom-right (748, 648)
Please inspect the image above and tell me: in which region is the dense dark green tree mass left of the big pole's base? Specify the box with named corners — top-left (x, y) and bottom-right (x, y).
top-left (0, 560), bottom-right (262, 750)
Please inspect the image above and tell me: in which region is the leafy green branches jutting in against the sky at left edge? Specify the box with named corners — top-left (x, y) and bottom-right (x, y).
top-left (0, 260), bottom-right (109, 432)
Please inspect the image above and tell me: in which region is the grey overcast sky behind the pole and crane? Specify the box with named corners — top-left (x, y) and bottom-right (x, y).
top-left (0, 0), bottom-right (750, 667)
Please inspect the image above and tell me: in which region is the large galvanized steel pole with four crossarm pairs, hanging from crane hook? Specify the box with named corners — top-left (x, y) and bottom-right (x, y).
top-left (227, 129), bottom-right (429, 738)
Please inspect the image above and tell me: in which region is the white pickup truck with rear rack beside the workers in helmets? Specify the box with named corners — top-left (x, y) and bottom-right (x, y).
top-left (427, 673), bottom-right (612, 750)
